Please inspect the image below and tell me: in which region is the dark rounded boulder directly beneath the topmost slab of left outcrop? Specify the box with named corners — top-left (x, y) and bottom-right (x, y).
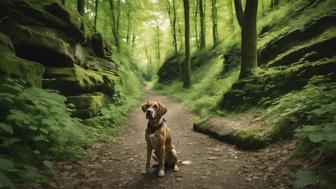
top-left (0, 17), bottom-right (74, 66)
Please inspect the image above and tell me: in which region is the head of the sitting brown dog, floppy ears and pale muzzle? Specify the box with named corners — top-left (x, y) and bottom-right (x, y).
top-left (141, 101), bottom-right (167, 119)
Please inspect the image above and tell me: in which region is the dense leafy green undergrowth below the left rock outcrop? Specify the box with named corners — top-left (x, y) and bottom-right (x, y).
top-left (0, 78), bottom-right (86, 188)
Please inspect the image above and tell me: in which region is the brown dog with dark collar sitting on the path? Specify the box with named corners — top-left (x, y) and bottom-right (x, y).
top-left (142, 101), bottom-right (178, 177)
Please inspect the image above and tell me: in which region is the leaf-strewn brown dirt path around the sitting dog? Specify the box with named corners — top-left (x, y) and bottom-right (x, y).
top-left (50, 90), bottom-right (296, 189)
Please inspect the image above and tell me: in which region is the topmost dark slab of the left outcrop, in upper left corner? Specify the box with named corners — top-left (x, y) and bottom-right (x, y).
top-left (0, 0), bottom-right (85, 42)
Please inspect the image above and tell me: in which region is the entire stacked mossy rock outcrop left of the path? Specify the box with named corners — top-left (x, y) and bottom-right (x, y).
top-left (0, 0), bottom-right (120, 119)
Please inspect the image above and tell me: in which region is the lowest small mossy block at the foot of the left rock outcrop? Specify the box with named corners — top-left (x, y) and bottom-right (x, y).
top-left (67, 92), bottom-right (105, 119)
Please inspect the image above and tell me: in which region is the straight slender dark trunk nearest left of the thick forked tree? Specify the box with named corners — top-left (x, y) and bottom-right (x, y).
top-left (183, 0), bottom-right (191, 88)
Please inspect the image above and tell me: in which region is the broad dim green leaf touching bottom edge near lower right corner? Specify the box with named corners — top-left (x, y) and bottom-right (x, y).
top-left (293, 171), bottom-right (317, 189)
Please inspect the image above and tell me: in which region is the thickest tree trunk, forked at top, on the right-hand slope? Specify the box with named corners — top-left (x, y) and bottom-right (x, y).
top-left (234, 0), bottom-right (258, 78)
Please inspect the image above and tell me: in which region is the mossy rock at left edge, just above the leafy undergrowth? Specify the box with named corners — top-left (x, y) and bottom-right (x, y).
top-left (0, 51), bottom-right (44, 87)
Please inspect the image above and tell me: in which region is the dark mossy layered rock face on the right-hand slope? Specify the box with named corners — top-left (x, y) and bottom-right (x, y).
top-left (221, 4), bottom-right (336, 110)
